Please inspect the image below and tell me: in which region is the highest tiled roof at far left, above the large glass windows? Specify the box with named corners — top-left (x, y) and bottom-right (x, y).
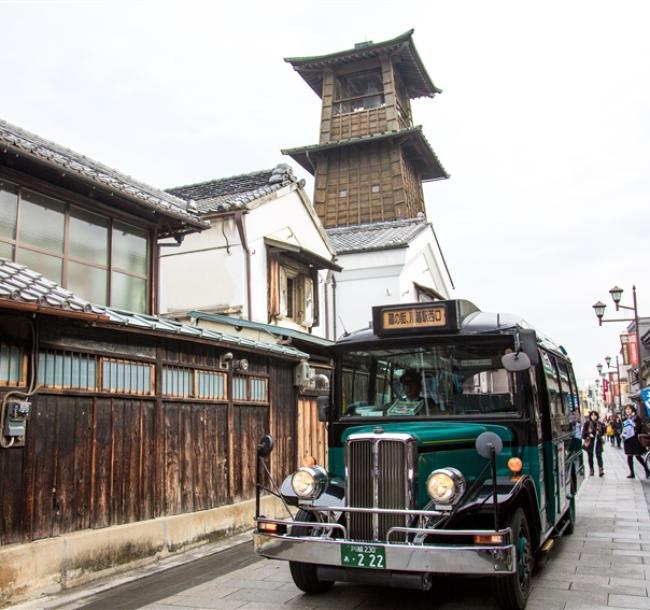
top-left (0, 120), bottom-right (208, 228)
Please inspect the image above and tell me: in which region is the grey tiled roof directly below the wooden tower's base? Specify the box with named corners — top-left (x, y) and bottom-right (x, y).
top-left (327, 218), bottom-right (431, 254)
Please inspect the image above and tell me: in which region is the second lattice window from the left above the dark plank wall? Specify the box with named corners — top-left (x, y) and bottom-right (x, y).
top-left (38, 350), bottom-right (97, 391)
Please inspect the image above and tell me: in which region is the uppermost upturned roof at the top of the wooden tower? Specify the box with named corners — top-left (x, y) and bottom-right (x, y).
top-left (284, 29), bottom-right (442, 99)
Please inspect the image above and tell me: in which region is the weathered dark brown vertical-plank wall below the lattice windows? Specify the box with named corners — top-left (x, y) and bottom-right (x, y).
top-left (0, 320), bottom-right (296, 545)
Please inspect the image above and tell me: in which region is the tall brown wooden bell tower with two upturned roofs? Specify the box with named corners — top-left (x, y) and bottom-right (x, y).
top-left (282, 30), bottom-right (449, 228)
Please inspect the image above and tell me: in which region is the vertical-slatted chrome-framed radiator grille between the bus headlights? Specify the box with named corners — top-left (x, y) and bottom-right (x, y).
top-left (346, 434), bottom-right (416, 541)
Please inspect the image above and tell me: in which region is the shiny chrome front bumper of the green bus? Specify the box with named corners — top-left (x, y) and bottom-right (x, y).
top-left (254, 530), bottom-right (517, 576)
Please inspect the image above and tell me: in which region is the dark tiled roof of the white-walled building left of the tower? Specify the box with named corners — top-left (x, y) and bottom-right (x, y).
top-left (167, 163), bottom-right (304, 214)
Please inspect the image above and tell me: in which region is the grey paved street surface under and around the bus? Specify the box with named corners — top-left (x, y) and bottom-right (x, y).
top-left (16, 447), bottom-right (650, 610)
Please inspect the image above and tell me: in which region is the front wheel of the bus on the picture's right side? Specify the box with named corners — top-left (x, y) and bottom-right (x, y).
top-left (495, 508), bottom-right (533, 610)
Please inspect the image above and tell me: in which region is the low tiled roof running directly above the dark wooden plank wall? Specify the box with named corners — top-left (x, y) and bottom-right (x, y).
top-left (0, 258), bottom-right (308, 359)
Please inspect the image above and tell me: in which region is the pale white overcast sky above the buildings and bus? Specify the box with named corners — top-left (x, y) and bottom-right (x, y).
top-left (0, 0), bottom-right (650, 383)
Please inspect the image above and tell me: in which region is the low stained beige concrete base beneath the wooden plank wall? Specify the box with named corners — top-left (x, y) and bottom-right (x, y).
top-left (0, 497), bottom-right (287, 607)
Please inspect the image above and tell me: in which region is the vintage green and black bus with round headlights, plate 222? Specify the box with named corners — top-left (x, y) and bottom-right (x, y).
top-left (254, 300), bottom-right (584, 609)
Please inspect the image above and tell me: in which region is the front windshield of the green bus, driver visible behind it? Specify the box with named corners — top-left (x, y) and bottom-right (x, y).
top-left (340, 338), bottom-right (525, 418)
